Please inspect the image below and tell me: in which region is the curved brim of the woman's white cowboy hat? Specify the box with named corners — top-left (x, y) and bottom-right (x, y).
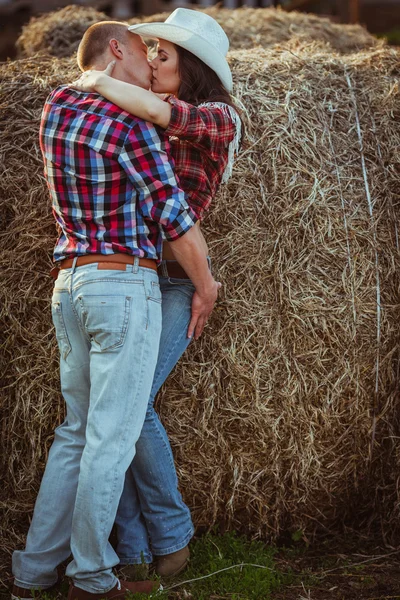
top-left (129, 23), bottom-right (233, 92)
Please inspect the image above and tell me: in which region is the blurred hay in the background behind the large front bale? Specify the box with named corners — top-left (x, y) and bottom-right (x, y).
top-left (17, 6), bottom-right (383, 57)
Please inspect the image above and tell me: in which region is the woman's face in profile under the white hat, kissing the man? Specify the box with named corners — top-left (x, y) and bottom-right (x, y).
top-left (150, 40), bottom-right (181, 95)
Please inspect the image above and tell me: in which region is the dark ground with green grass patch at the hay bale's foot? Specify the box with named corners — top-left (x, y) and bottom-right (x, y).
top-left (0, 533), bottom-right (400, 600)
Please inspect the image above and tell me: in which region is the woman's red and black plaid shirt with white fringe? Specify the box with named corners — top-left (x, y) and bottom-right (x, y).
top-left (165, 96), bottom-right (236, 219)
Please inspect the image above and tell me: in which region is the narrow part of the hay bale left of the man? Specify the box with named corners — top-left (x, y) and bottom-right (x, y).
top-left (0, 56), bottom-right (78, 588)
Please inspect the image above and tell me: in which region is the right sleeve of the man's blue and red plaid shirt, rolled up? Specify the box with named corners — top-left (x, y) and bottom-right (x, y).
top-left (119, 121), bottom-right (198, 241)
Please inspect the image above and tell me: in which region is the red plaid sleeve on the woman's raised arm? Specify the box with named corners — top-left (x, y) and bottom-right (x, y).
top-left (165, 96), bottom-right (236, 154)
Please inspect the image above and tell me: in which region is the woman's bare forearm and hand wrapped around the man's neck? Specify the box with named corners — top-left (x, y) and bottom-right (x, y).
top-left (70, 62), bottom-right (172, 129)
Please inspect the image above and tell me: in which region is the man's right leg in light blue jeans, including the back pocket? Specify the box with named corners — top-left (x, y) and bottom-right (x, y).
top-left (67, 265), bottom-right (161, 593)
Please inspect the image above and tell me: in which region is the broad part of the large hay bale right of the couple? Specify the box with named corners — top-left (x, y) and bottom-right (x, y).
top-left (180, 44), bottom-right (400, 537)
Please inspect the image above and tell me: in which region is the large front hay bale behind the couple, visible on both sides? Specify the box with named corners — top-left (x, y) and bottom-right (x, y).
top-left (0, 41), bottom-right (400, 592)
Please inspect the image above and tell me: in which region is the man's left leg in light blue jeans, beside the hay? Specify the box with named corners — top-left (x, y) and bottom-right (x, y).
top-left (13, 271), bottom-right (90, 590)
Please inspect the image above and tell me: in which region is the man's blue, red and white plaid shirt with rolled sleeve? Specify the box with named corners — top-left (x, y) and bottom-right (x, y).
top-left (40, 86), bottom-right (197, 261)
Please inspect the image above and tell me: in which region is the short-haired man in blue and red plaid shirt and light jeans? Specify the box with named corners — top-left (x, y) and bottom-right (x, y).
top-left (13, 22), bottom-right (218, 600)
